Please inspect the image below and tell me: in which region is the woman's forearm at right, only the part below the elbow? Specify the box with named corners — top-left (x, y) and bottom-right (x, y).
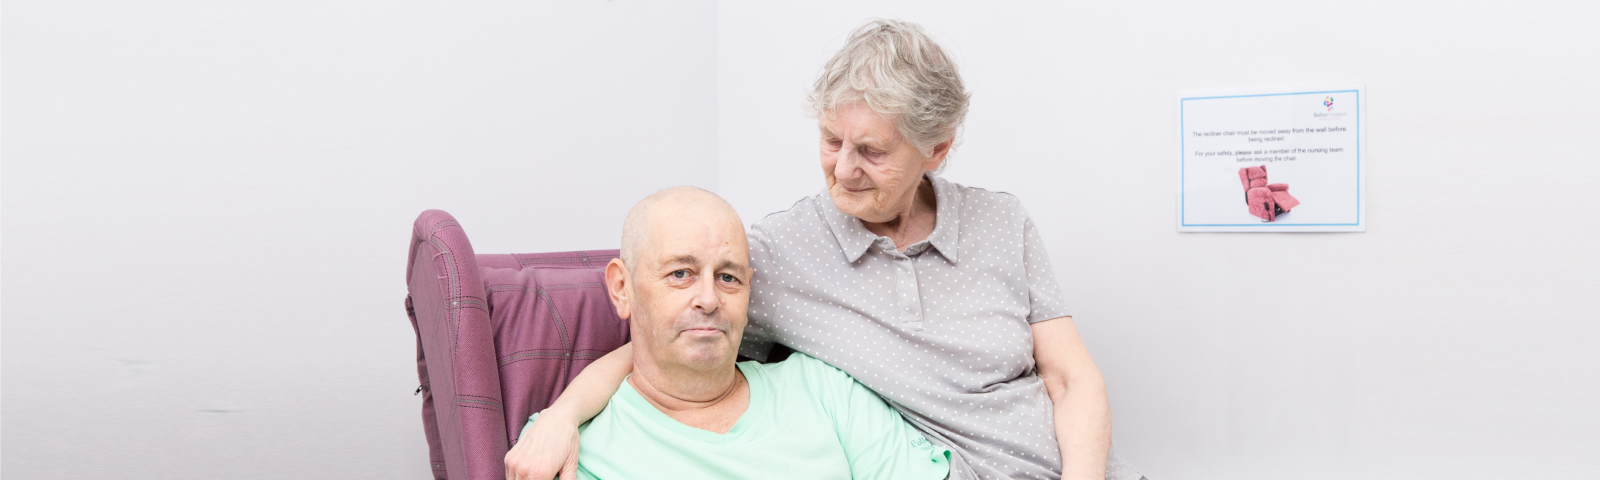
top-left (1050, 376), bottom-right (1110, 480)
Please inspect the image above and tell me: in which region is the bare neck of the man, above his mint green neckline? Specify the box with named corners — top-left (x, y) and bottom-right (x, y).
top-left (627, 357), bottom-right (750, 434)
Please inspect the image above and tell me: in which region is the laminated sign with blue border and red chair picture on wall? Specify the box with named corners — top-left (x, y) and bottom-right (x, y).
top-left (1178, 85), bottom-right (1366, 232)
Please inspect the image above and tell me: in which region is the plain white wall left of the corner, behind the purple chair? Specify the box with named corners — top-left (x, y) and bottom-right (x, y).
top-left (3, 2), bottom-right (717, 478)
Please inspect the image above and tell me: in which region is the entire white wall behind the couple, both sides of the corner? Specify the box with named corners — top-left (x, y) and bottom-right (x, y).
top-left (0, 0), bottom-right (1600, 478)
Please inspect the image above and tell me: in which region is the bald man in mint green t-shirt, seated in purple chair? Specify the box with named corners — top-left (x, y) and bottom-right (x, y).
top-left (506, 187), bottom-right (950, 480)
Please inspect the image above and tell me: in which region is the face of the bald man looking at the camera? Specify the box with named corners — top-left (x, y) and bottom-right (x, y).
top-left (608, 205), bottom-right (750, 370)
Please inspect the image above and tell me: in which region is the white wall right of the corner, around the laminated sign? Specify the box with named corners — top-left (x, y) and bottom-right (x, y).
top-left (717, 2), bottom-right (1600, 478)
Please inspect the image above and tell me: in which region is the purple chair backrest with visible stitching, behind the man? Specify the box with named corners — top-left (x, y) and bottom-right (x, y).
top-left (406, 210), bottom-right (629, 480)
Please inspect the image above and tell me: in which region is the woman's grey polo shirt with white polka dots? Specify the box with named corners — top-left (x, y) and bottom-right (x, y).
top-left (741, 176), bottom-right (1139, 480)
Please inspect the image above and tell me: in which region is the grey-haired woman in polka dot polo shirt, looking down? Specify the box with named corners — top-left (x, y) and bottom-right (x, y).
top-left (507, 21), bottom-right (1141, 480)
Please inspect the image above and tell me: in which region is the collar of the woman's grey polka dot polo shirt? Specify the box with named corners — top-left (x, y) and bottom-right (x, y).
top-left (821, 173), bottom-right (962, 264)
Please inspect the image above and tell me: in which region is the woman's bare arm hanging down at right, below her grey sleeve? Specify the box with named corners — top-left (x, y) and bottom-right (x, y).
top-left (1032, 317), bottom-right (1110, 480)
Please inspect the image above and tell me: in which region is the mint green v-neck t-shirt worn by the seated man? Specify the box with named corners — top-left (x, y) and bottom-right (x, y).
top-left (523, 354), bottom-right (950, 480)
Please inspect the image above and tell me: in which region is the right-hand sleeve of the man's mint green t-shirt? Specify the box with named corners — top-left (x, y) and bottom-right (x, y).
top-left (789, 354), bottom-right (950, 480)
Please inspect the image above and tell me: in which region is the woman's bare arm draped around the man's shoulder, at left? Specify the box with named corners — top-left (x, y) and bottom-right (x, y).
top-left (506, 342), bottom-right (634, 480)
